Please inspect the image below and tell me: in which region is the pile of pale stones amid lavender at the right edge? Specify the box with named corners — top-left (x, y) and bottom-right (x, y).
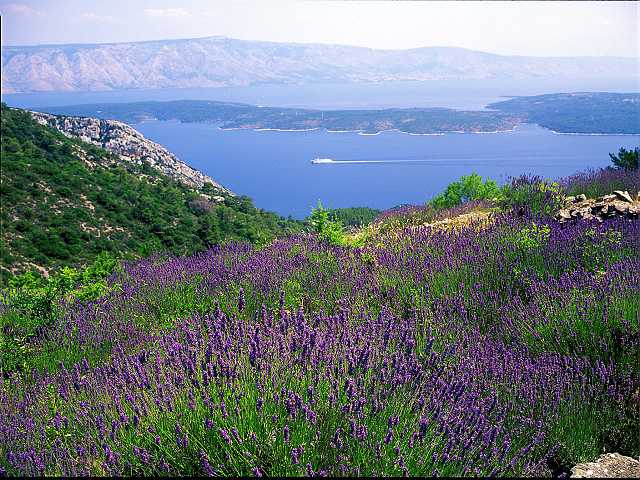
top-left (555, 190), bottom-right (640, 223)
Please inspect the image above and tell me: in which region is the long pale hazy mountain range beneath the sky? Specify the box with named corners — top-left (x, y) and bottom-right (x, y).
top-left (1, 37), bottom-right (638, 93)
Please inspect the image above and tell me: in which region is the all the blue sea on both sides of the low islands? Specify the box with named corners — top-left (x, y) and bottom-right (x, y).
top-left (2, 79), bottom-right (640, 218)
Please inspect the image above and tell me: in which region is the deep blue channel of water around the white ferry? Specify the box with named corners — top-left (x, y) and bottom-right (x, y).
top-left (134, 121), bottom-right (640, 218)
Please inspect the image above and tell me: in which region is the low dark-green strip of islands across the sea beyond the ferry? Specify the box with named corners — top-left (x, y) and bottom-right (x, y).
top-left (35, 92), bottom-right (640, 135)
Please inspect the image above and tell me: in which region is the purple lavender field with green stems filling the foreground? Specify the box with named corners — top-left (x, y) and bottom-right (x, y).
top-left (0, 170), bottom-right (640, 476)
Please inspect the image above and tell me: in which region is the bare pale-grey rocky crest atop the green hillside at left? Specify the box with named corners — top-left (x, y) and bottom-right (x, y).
top-left (30, 112), bottom-right (233, 195)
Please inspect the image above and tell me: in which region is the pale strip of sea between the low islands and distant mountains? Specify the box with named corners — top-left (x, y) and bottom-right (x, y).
top-left (2, 77), bottom-right (640, 110)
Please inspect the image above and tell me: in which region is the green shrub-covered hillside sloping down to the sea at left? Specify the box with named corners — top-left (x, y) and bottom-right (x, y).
top-left (0, 104), bottom-right (301, 279)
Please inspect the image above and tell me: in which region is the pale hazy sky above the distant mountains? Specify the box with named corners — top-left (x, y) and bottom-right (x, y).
top-left (0, 0), bottom-right (640, 57)
